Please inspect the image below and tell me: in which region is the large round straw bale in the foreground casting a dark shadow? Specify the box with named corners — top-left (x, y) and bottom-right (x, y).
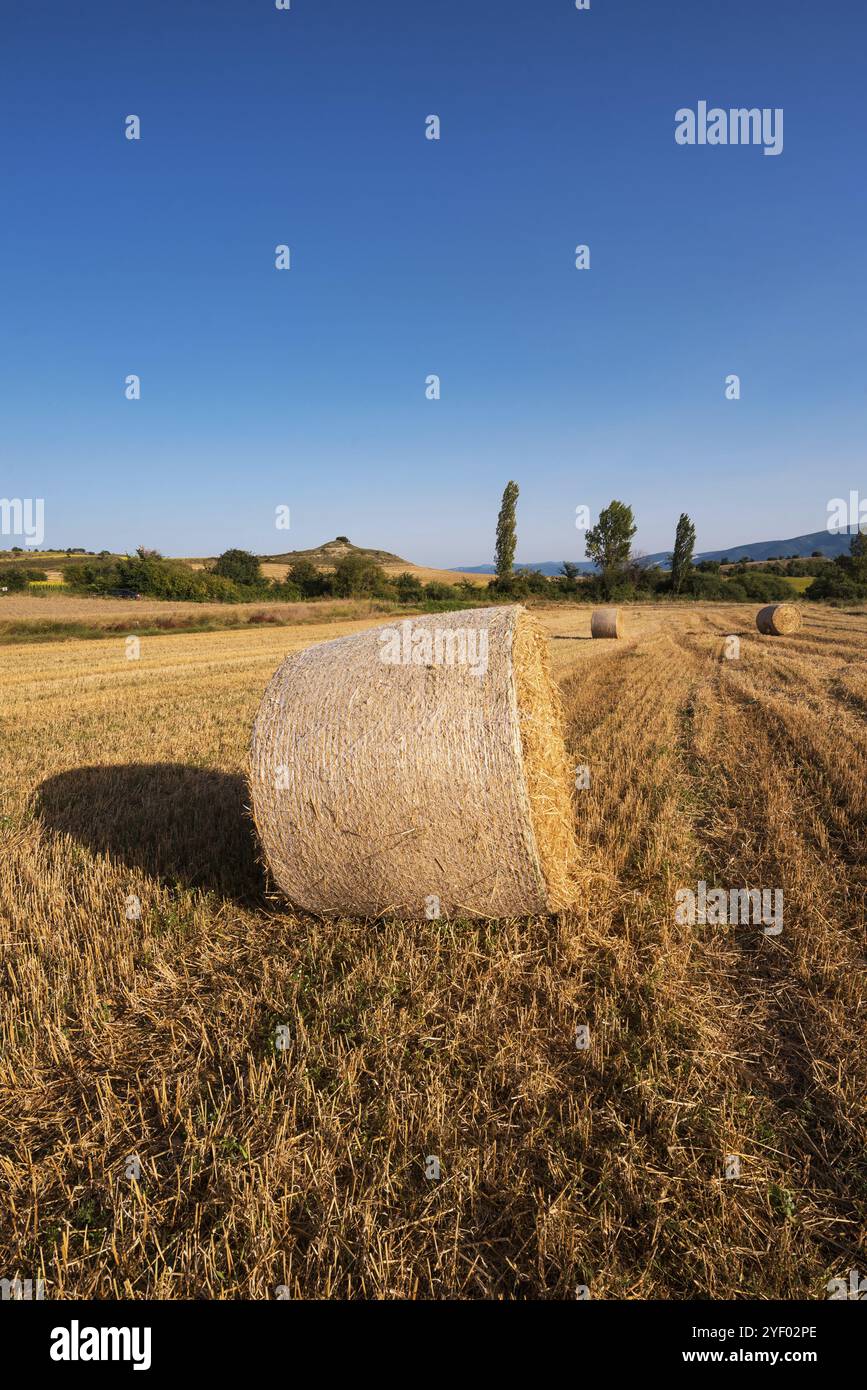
top-left (250, 606), bottom-right (577, 919)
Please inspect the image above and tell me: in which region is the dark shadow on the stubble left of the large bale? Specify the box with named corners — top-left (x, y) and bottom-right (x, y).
top-left (33, 763), bottom-right (265, 902)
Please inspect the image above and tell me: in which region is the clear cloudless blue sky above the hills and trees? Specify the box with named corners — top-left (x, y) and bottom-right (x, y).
top-left (0, 0), bottom-right (867, 566)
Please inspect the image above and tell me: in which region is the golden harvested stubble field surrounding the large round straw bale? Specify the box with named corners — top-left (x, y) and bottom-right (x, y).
top-left (0, 605), bottom-right (867, 1298)
